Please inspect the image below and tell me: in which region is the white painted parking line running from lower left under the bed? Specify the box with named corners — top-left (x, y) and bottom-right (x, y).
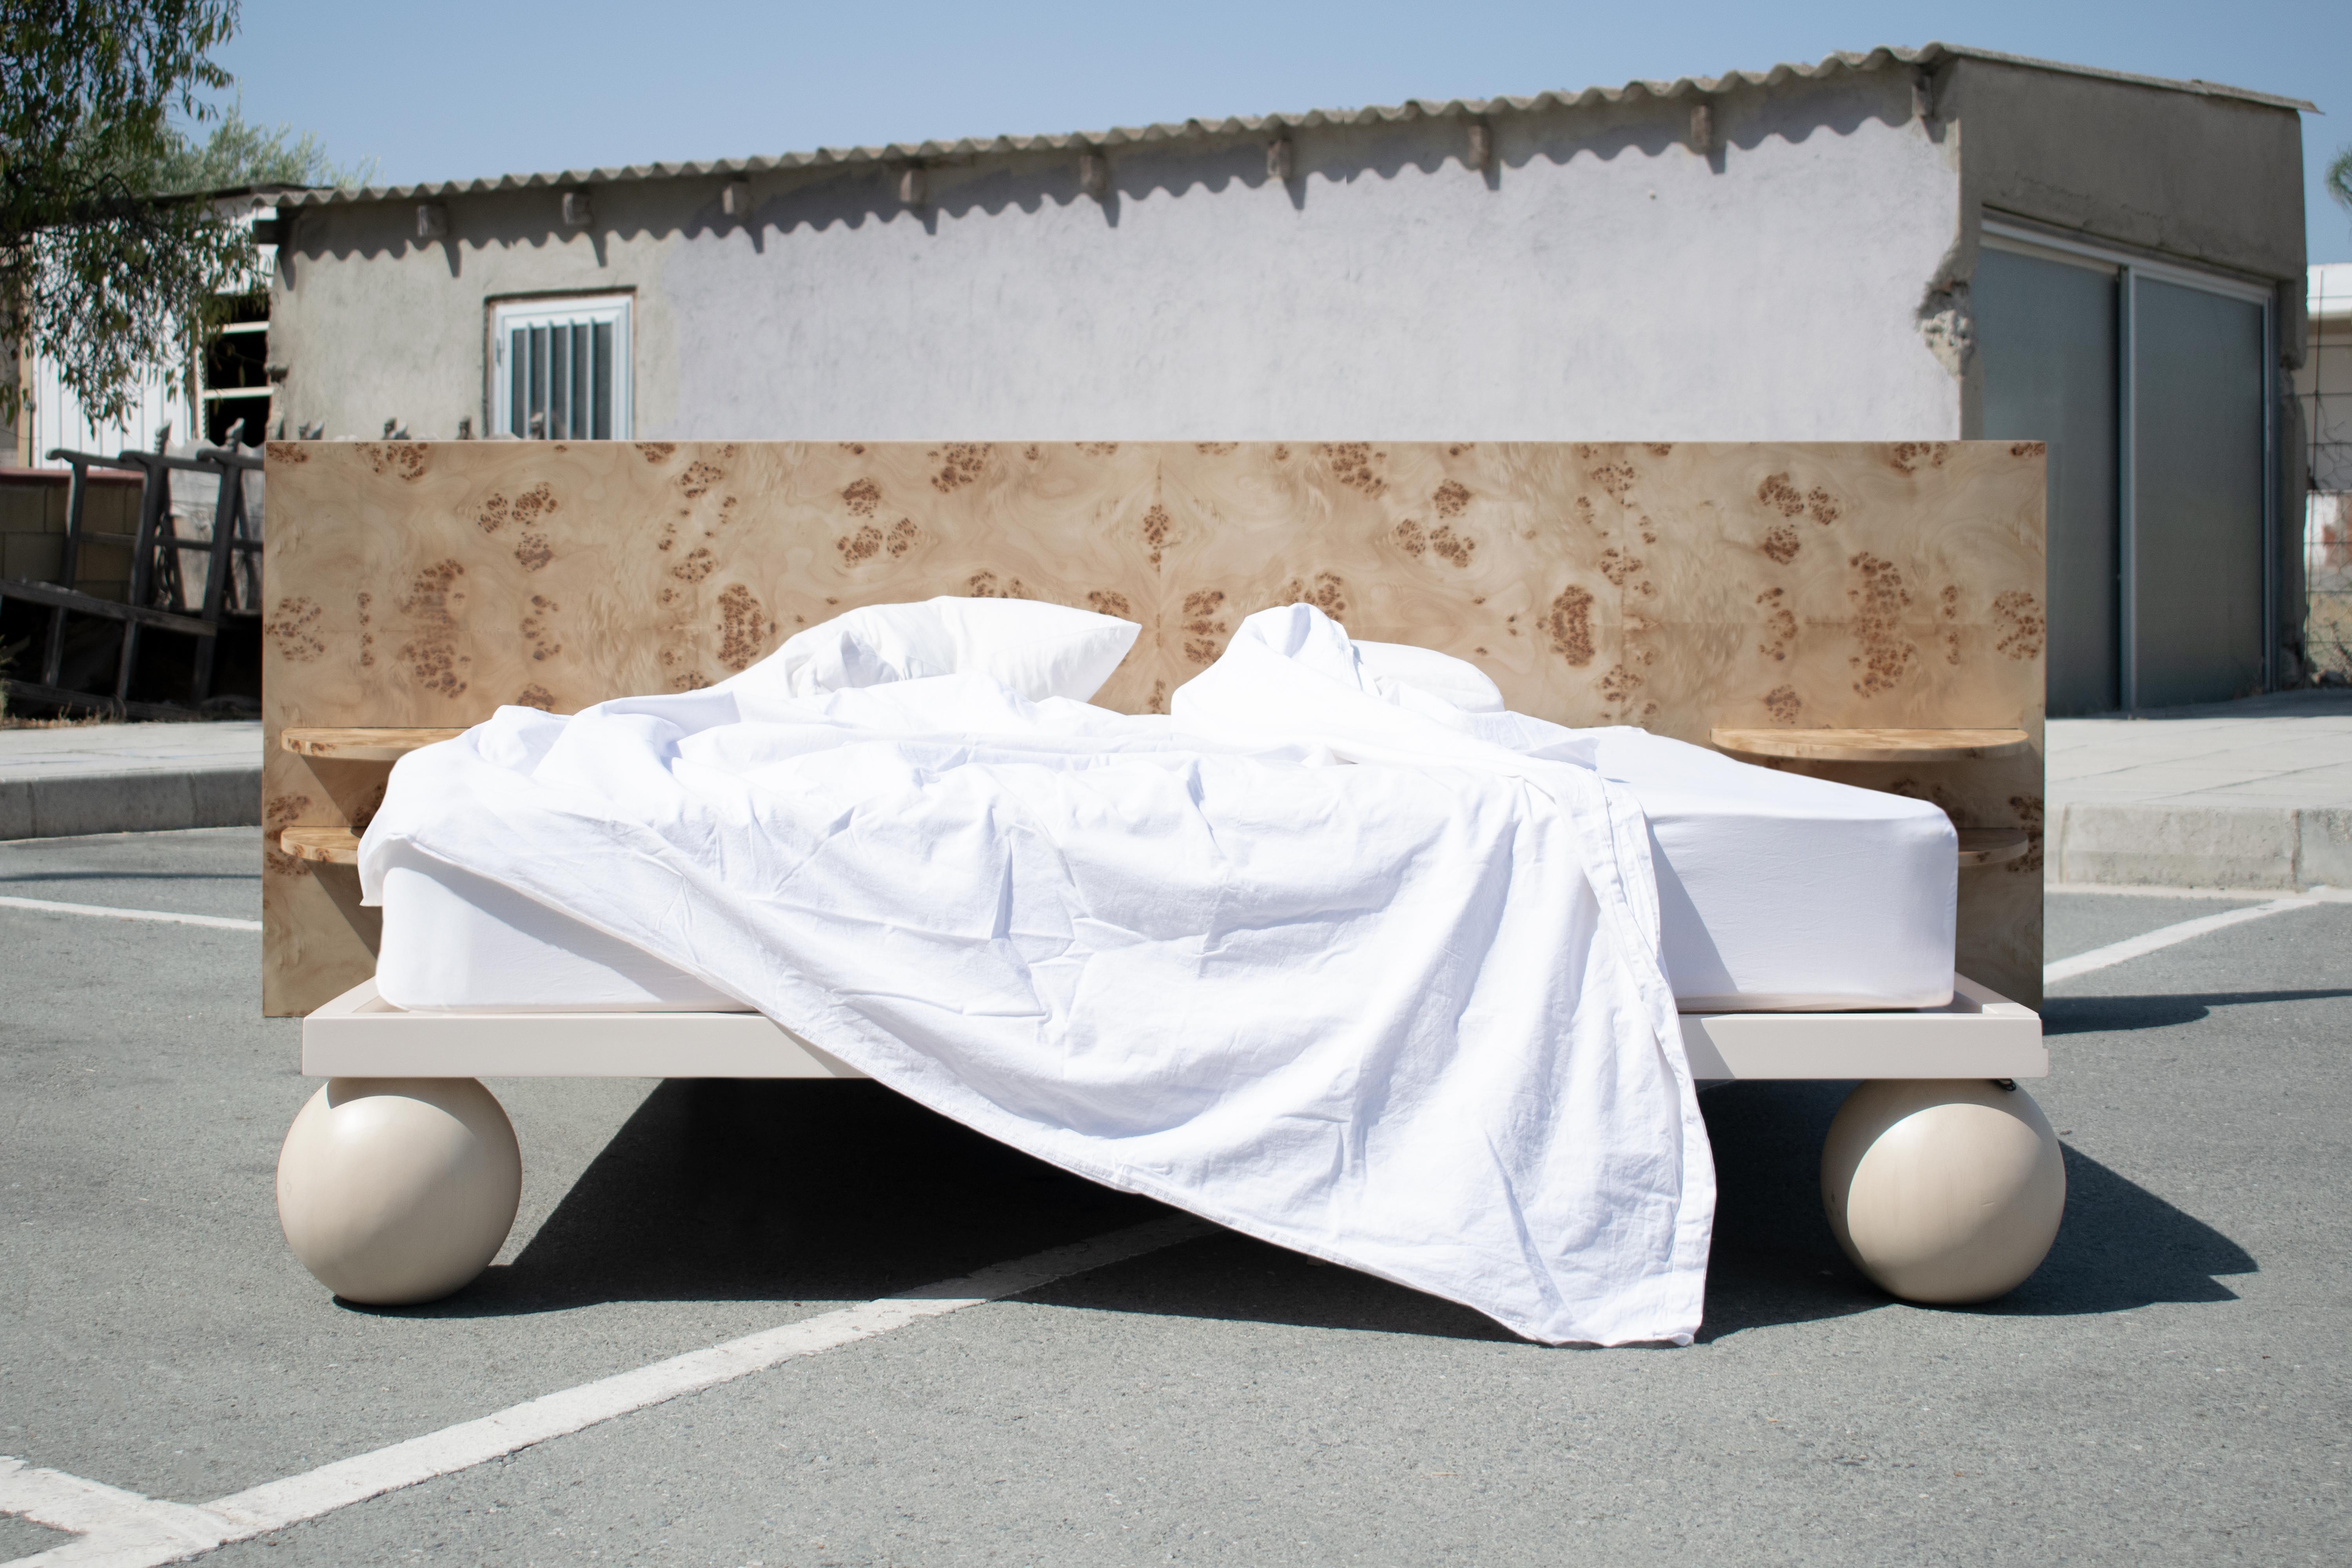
top-left (0, 1215), bottom-right (1209, 1568)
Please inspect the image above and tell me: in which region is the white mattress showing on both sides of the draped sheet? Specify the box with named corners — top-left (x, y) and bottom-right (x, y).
top-left (376, 729), bottom-right (1957, 1013)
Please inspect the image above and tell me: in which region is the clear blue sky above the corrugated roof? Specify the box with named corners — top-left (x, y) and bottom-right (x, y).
top-left (221, 0), bottom-right (2352, 261)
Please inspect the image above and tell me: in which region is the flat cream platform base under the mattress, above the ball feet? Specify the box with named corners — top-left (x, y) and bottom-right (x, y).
top-left (301, 976), bottom-right (2051, 1082)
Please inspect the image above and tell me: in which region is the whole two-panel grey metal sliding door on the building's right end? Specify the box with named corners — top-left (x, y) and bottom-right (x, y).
top-left (1971, 219), bottom-right (2277, 715)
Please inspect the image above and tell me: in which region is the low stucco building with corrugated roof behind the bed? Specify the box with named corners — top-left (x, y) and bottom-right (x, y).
top-left (248, 47), bottom-right (2307, 712)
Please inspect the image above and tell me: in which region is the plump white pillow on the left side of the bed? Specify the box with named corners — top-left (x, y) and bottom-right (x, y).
top-left (722, 597), bottom-right (1143, 703)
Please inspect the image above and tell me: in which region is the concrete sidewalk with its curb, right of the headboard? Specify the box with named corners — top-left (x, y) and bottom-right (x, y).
top-left (2049, 691), bottom-right (2352, 889)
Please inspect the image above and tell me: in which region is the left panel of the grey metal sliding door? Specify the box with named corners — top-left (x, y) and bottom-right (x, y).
top-left (1973, 249), bottom-right (2122, 715)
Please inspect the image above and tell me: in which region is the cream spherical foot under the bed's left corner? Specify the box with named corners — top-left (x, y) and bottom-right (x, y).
top-left (278, 1079), bottom-right (522, 1307)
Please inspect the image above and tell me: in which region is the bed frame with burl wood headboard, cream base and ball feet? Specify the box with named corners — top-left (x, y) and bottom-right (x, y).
top-left (261, 442), bottom-right (2065, 1335)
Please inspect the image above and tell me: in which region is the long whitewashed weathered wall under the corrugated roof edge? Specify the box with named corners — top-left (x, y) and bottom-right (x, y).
top-left (270, 71), bottom-right (1962, 439)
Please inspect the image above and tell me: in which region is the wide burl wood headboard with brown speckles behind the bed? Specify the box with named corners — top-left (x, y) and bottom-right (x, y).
top-left (263, 442), bottom-right (2044, 1013)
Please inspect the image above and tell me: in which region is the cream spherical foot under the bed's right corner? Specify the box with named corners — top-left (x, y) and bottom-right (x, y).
top-left (1820, 1079), bottom-right (2065, 1307)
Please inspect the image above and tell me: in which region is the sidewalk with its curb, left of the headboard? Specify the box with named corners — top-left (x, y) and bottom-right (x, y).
top-left (0, 722), bottom-right (261, 839)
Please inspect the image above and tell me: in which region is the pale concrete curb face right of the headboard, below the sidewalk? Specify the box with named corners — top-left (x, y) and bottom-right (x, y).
top-left (2046, 804), bottom-right (2352, 889)
